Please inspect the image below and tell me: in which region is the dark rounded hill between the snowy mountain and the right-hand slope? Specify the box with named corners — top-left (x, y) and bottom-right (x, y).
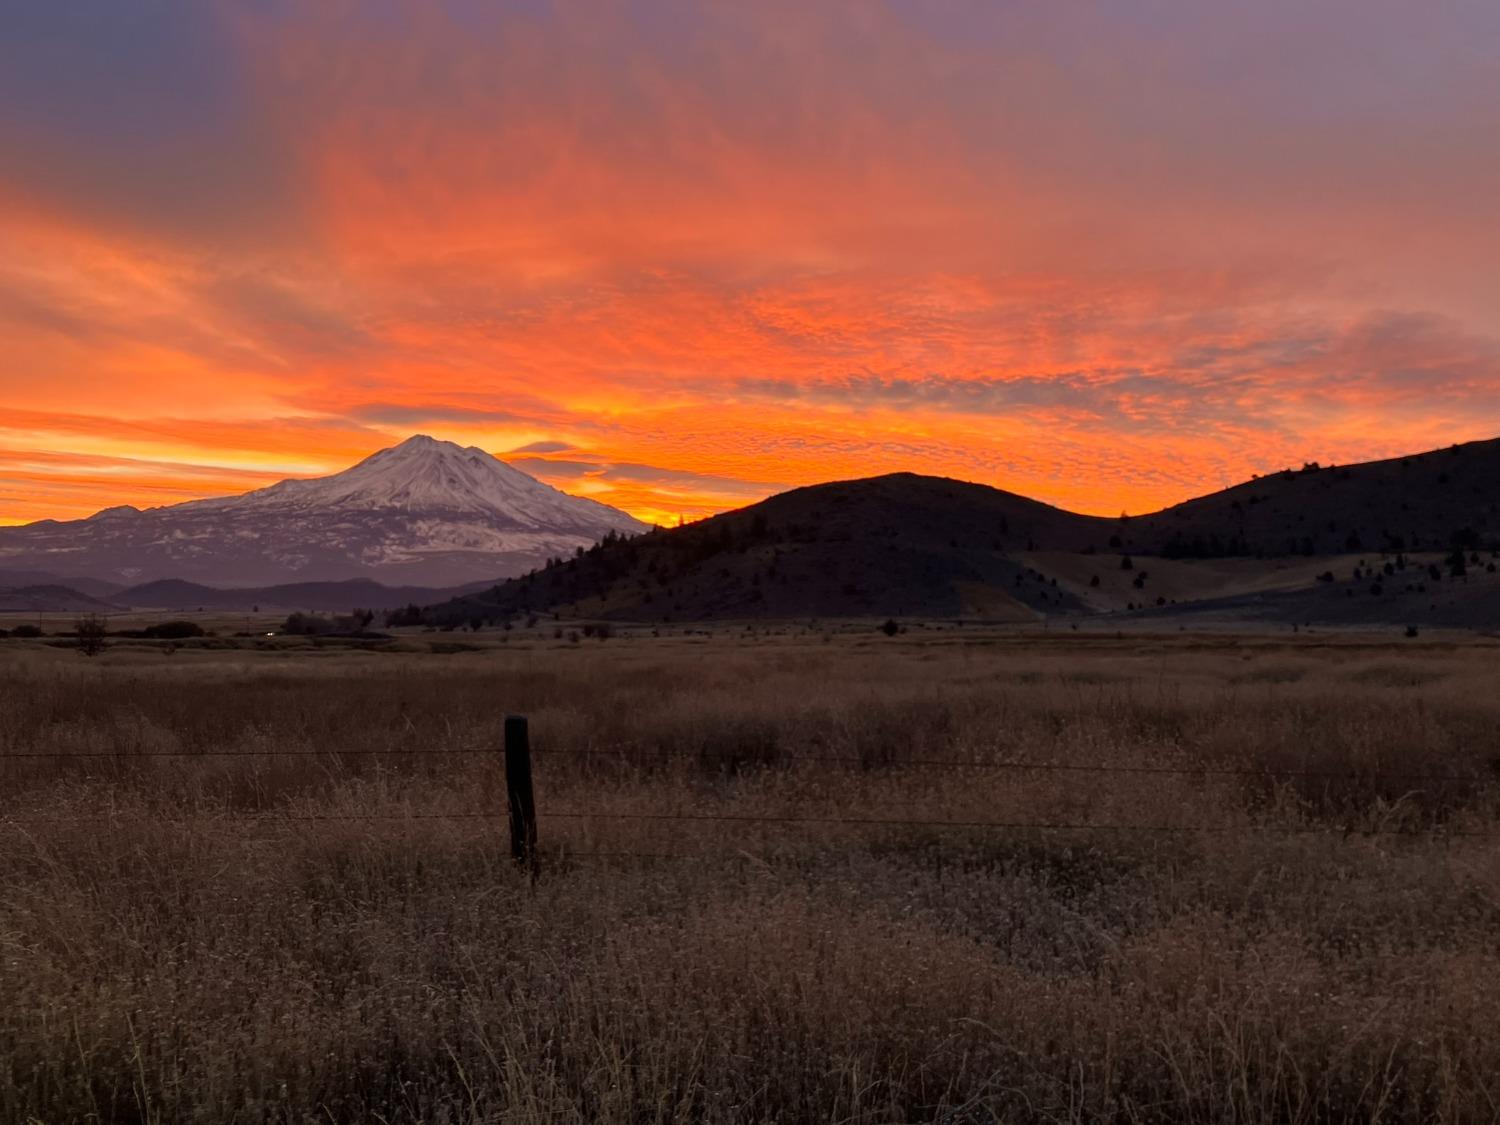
top-left (435, 473), bottom-right (1110, 621)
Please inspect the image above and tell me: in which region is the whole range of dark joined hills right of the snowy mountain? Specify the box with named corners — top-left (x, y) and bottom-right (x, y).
top-left (431, 441), bottom-right (1500, 626)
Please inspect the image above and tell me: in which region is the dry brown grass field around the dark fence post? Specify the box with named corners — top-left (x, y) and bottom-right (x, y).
top-left (0, 630), bottom-right (1500, 1122)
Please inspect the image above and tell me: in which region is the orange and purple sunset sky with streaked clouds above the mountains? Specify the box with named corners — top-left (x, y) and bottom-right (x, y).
top-left (0, 0), bottom-right (1500, 524)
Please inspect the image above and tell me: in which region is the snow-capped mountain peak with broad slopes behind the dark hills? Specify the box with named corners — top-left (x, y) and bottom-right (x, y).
top-left (0, 435), bottom-right (647, 587)
